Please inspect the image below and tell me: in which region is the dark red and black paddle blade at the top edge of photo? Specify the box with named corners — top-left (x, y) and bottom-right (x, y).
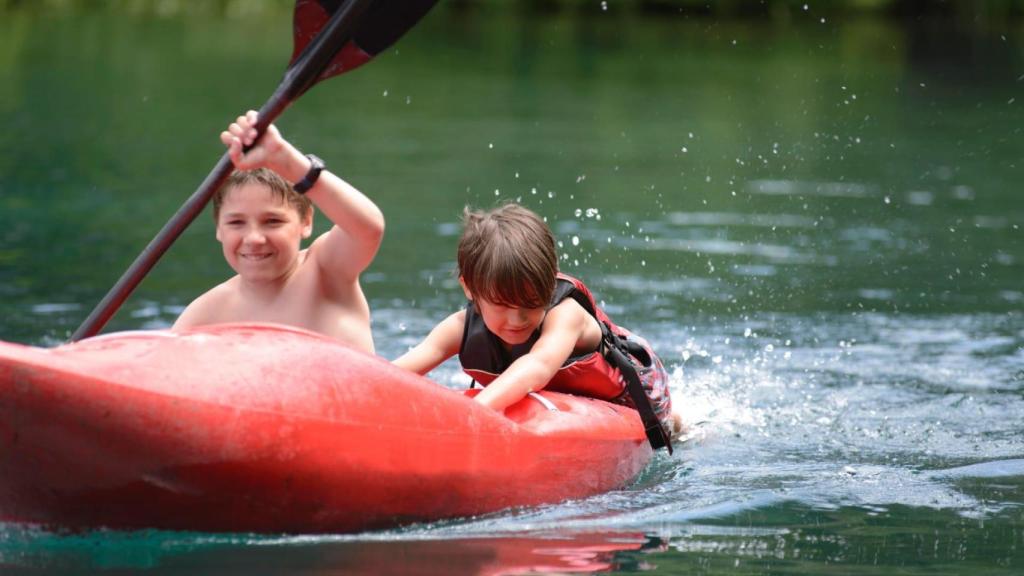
top-left (289, 0), bottom-right (437, 82)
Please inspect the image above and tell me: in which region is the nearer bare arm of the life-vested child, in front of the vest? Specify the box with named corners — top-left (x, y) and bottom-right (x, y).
top-left (474, 299), bottom-right (590, 411)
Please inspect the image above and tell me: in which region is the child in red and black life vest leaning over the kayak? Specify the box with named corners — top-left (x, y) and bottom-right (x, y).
top-left (394, 204), bottom-right (681, 451)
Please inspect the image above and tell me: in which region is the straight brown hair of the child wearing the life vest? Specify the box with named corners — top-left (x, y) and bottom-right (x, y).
top-left (459, 204), bottom-right (558, 307)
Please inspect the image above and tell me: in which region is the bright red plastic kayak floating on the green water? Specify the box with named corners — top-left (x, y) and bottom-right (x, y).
top-left (0, 324), bottom-right (651, 533)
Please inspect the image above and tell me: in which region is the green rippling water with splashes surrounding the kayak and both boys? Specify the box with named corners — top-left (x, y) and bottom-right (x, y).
top-left (0, 5), bottom-right (1024, 574)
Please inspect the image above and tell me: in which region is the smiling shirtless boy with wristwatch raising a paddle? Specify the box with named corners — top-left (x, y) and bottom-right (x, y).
top-left (173, 111), bottom-right (384, 353)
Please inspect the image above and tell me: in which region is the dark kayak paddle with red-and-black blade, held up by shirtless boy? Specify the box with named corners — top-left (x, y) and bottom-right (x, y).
top-left (71, 0), bottom-right (437, 341)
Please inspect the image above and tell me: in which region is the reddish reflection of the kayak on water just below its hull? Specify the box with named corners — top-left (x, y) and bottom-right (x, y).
top-left (0, 525), bottom-right (668, 576)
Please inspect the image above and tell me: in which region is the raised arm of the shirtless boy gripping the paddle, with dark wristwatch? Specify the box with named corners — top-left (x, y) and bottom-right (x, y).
top-left (220, 111), bottom-right (384, 283)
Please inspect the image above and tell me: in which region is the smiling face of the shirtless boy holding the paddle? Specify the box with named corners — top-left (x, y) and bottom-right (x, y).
top-left (217, 182), bottom-right (312, 282)
